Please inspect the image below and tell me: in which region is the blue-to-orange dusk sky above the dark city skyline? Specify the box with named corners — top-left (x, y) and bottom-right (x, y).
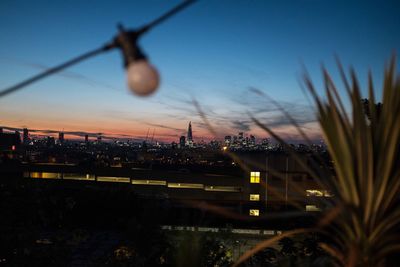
top-left (0, 0), bottom-right (400, 142)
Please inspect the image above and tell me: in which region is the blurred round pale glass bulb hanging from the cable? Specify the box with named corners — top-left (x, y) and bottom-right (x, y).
top-left (126, 59), bottom-right (160, 96)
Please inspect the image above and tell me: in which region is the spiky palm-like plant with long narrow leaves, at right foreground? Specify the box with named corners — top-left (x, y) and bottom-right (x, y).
top-left (234, 58), bottom-right (400, 267)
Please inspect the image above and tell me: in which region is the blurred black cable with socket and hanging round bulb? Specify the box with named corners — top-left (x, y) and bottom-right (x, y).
top-left (0, 0), bottom-right (195, 97)
